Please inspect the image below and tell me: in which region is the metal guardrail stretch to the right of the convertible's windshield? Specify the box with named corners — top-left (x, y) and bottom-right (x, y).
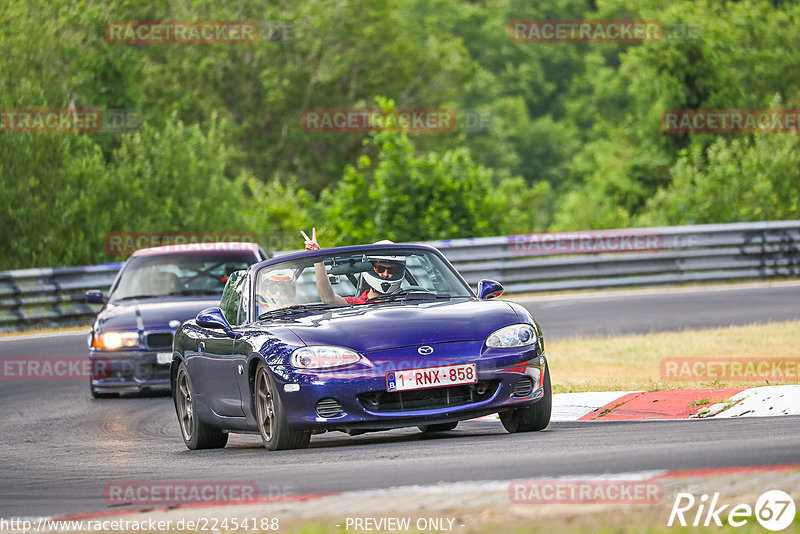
top-left (422, 221), bottom-right (800, 293)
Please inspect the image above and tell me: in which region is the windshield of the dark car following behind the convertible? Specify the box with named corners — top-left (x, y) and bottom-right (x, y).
top-left (110, 252), bottom-right (255, 301)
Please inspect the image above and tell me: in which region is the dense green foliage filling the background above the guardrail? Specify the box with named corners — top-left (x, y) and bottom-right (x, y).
top-left (0, 0), bottom-right (800, 269)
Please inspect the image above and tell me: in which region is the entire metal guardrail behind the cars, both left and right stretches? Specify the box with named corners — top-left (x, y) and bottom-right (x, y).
top-left (0, 221), bottom-right (800, 331)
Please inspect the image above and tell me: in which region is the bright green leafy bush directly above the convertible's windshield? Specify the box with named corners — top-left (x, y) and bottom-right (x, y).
top-left (322, 99), bottom-right (502, 244)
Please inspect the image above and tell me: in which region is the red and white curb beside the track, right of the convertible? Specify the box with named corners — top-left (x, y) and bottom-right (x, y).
top-left (551, 385), bottom-right (800, 422)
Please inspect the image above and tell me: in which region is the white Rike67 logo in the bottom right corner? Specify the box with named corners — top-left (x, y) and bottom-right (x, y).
top-left (667, 490), bottom-right (795, 531)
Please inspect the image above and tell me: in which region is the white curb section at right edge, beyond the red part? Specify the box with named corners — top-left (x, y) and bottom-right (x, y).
top-left (694, 385), bottom-right (800, 418)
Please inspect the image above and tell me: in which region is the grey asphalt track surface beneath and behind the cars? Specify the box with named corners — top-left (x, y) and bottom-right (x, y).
top-left (0, 284), bottom-right (800, 518)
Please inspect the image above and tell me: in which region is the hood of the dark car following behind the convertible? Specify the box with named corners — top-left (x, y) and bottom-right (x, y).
top-left (95, 296), bottom-right (219, 332)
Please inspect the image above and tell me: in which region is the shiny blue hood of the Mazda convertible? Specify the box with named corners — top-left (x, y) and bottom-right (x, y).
top-left (276, 299), bottom-right (520, 353)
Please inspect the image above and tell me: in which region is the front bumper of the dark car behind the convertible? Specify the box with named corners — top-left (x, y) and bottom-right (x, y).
top-left (89, 349), bottom-right (171, 393)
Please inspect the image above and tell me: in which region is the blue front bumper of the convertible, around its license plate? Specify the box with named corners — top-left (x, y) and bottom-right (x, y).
top-left (272, 342), bottom-right (545, 431)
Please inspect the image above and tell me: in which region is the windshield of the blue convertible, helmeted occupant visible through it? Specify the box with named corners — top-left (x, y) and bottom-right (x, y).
top-left (255, 248), bottom-right (473, 317)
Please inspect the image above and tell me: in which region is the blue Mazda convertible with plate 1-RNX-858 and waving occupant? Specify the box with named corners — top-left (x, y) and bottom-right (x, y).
top-left (170, 244), bottom-right (552, 450)
